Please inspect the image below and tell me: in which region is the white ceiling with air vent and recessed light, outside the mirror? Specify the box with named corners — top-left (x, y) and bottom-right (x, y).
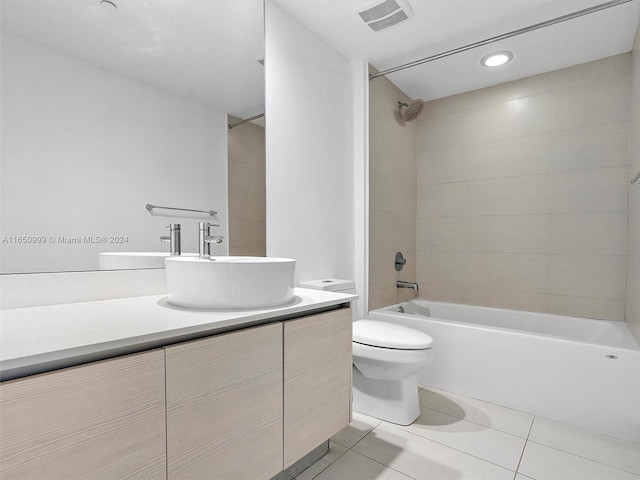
top-left (273, 0), bottom-right (640, 100)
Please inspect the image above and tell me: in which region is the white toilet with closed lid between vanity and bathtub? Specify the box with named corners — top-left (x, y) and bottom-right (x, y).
top-left (300, 278), bottom-right (434, 425)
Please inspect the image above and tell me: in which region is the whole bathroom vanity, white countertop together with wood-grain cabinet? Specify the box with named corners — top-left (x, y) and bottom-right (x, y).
top-left (0, 289), bottom-right (355, 480)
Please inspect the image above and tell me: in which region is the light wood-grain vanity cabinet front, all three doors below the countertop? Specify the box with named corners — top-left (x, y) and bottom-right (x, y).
top-left (0, 308), bottom-right (352, 480)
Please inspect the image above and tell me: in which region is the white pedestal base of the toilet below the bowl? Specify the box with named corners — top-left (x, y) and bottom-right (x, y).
top-left (353, 366), bottom-right (420, 425)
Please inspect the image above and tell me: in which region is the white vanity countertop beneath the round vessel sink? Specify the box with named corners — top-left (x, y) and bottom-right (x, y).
top-left (0, 288), bottom-right (357, 380)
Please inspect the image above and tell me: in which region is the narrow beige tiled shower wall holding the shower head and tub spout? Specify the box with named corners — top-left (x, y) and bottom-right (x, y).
top-left (368, 70), bottom-right (416, 310)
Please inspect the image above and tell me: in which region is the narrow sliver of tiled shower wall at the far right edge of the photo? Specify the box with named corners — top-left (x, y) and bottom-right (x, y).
top-left (626, 35), bottom-right (640, 344)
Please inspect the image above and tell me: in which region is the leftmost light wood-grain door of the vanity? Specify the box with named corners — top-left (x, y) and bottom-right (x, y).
top-left (0, 349), bottom-right (166, 480)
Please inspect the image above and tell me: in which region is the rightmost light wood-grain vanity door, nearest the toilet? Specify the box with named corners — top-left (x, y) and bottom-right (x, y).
top-left (284, 308), bottom-right (352, 468)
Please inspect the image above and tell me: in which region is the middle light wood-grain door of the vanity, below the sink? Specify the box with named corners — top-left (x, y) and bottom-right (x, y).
top-left (166, 322), bottom-right (282, 480)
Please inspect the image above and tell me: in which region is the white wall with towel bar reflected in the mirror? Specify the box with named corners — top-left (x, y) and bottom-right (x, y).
top-left (0, 32), bottom-right (227, 273)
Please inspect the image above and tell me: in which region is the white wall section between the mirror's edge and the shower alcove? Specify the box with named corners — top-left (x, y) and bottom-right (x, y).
top-left (265, 2), bottom-right (355, 281)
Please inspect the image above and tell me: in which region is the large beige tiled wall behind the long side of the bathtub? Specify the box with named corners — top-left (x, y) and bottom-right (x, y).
top-left (416, 54), bottom-right (638, 320)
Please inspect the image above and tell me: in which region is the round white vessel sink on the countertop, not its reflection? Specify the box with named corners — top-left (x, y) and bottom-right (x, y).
top-left (165, 256), bottom-right (296, 309)
